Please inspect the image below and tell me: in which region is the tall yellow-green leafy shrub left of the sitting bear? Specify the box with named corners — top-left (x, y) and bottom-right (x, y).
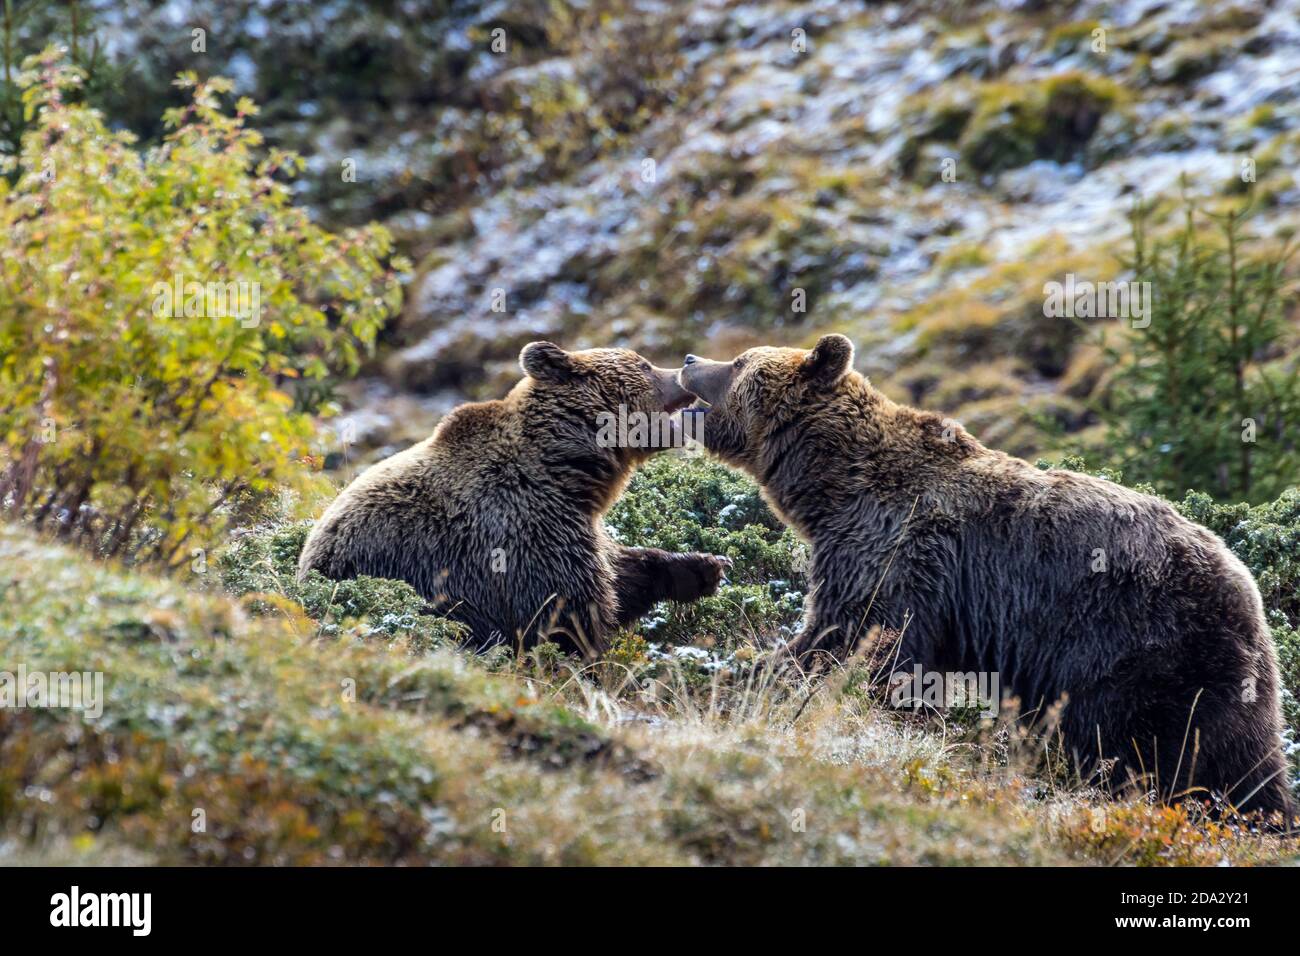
top-left (0, 51), bottom-right (403, 564)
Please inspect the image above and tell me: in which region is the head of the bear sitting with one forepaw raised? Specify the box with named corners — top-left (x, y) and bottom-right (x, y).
top-left (519, 342), bottom-right (694, 462)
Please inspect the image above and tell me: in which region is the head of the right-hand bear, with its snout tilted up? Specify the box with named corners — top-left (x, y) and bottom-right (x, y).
top-left (679, 334), bottom-right (861, 476)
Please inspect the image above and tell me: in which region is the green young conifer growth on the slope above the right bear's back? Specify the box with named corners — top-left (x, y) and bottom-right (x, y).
top-left (1101, 188), bottom-right (1300, 502)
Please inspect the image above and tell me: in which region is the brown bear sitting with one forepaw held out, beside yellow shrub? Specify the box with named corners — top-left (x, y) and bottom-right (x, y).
top-left (299, 342), bottom-right (727, 656)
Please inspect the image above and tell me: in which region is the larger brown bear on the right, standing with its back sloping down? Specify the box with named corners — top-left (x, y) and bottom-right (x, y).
top-left (681, 336), bottom-right (1288, 812)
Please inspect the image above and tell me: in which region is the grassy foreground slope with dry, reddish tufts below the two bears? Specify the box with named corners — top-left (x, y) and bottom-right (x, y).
top-left (0, 478), bottom-right (1294, 864)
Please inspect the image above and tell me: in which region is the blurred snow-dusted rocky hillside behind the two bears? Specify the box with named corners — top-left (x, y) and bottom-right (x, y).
top-left (18, 0), bottom-right (1300, 463)
